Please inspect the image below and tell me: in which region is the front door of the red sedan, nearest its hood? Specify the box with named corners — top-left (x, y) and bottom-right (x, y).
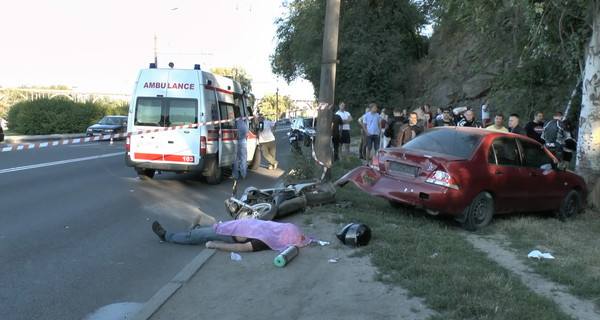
top-left (518, 139), bottom-right (564, 211)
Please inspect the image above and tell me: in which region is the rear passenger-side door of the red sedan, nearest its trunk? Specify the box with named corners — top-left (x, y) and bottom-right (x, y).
top-left (488, 136), bottom-right (529, 213)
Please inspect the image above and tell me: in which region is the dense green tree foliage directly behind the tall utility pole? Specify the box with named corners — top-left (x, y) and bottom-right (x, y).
top-left (271, 0), bottom-right (427, 109)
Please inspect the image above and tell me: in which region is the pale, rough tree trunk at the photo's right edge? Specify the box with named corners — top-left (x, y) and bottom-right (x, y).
top-left (576, 0), bottom-right (600, 208)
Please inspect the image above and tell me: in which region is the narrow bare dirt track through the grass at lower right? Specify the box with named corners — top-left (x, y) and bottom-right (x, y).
top-left (466, 233), bottom-right (600, 320)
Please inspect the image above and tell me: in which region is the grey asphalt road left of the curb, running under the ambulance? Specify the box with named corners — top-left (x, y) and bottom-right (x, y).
top-left (0, 128), bottom-right (289, 320)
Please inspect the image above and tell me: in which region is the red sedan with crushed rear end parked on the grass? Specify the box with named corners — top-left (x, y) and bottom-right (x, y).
top-left (336, 127), bottom-right (587, 230)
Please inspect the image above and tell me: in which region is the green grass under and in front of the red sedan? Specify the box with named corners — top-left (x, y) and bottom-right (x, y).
top-left (288, 151), bottom-right (600, 320)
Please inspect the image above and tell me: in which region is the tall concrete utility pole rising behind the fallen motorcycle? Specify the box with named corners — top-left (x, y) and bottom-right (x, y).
top-left (315, 0), bottom-right (340, 180)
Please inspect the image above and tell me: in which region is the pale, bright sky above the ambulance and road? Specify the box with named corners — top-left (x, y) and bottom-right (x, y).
top-left (0, 0), bottom-right (313, 100)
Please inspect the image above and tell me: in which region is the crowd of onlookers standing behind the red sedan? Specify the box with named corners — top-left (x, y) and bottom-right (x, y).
top-left (332, 100), bottom-right (576, 163)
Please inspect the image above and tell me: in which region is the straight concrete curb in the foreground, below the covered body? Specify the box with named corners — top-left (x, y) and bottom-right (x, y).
top-left (132, 249), bottom-right (217, 320)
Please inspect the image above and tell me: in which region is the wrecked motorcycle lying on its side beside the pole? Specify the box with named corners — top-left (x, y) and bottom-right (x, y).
top-left (225, 182), bottom-right (335, 220)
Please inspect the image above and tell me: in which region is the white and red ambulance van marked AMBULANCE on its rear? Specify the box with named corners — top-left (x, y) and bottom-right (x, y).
top-left (125, 63), bottom-right (260, 184)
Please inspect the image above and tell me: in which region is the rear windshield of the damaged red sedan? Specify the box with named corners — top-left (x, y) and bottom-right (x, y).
top-left (402, 129), bottom-right (481, 159)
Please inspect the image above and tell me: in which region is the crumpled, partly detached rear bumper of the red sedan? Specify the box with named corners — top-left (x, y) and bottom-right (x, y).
top-left (335, 166), bottom-right (469, 217)
